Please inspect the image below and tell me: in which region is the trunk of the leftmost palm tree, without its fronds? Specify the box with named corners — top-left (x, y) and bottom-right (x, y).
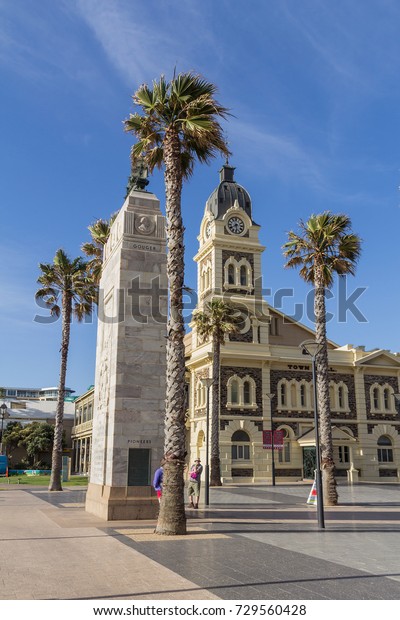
top-left (49, 292), bottom-right (72, 491)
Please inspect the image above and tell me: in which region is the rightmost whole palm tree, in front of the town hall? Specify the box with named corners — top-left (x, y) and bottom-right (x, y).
top-left (283, 211), bottom-right (361, 506)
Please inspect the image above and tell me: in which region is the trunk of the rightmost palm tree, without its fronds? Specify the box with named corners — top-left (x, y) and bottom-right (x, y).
top-left (314, 268), bottom-right (338, 506)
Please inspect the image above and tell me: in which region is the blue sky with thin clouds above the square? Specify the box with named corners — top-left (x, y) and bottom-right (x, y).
top-left (0, 0), bottom-right (400, 393)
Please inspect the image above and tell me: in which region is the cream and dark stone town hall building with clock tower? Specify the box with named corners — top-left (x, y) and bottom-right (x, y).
top-left (187, 167), bottom-right (400, 483)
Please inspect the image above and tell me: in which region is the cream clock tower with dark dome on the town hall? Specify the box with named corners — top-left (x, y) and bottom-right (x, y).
top-left (194, 164), bottom-right (268, 344)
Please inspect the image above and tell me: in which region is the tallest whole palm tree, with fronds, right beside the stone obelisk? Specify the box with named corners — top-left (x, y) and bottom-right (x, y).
top-left (125, 72), bottom-right (229, 535)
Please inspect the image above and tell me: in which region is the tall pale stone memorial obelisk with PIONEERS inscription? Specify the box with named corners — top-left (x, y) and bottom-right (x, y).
top-left (86, 170), bottom-right (167, 520)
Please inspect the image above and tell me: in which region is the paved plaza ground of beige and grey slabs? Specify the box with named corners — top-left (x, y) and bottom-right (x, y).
top-left (0, 484), bottom-right (400, 600)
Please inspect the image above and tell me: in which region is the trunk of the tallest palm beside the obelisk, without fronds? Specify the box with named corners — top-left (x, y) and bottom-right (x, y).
top-left (155, 129), bottom-right (186, 535)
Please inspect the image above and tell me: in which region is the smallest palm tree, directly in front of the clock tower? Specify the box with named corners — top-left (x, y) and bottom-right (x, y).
top-left (193, 299), bottom-right (237, 487)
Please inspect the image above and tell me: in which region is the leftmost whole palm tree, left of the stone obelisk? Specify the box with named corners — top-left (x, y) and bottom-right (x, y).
top-left (36, 249), bottom-right (97, 491)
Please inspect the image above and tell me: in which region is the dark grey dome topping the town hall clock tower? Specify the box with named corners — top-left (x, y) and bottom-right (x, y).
top-left (206, 164), bottom-right (252, 220)
